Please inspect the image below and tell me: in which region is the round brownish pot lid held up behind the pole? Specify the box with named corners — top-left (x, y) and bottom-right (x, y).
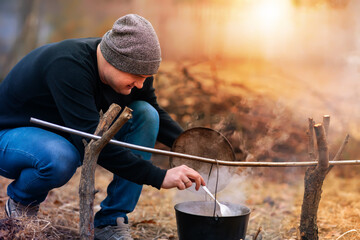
top-left (170, 127), bottom-right (236, 192)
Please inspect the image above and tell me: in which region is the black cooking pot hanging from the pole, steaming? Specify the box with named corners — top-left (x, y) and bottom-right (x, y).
top-left (175, 201), bottom-right (251, 240)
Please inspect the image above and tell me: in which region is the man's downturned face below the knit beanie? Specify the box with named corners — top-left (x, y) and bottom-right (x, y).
top-left (98, 45), bottom-right (151, 95)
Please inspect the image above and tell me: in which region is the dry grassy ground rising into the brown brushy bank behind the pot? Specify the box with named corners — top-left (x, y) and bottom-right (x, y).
top-left (0, 61), bottom-right (360, 240)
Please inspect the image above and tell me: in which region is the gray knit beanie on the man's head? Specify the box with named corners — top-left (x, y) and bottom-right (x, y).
top-left (100, 14), bottom-right (161, 75)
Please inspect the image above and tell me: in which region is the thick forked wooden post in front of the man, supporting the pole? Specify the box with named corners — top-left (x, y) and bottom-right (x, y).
top-left (79, 104), bottom-right (132, 239)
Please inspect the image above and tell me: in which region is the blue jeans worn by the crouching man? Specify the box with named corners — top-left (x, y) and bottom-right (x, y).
top-left (0, 101), bottom-right (159, 227)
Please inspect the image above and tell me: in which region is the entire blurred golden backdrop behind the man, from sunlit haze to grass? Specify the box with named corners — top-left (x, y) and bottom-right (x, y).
top-left (0, 0), bottom-right (360, 239)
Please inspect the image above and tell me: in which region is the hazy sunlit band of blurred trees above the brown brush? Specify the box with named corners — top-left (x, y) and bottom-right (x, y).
top-left (0, 0), bottom-right (360, 66)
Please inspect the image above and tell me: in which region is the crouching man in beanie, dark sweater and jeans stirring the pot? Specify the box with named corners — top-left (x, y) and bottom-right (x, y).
top-left (0, 14), bottom-right (205, 239)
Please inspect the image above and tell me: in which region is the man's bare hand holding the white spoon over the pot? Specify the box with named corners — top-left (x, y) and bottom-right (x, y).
top-left (161, 165), bottom-right (205, 190)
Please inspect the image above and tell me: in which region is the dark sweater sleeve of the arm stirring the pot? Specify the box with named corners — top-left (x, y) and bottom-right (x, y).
top-left (46, 59), bottom-right (166, 189)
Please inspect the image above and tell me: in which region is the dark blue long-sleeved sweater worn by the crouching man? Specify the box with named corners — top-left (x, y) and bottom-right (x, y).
top-left (0, 38), bottom-right (182, 188)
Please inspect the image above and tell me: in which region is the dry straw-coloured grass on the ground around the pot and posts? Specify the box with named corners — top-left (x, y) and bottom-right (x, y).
top-left (0, 169), bottom-right (360, 240)
